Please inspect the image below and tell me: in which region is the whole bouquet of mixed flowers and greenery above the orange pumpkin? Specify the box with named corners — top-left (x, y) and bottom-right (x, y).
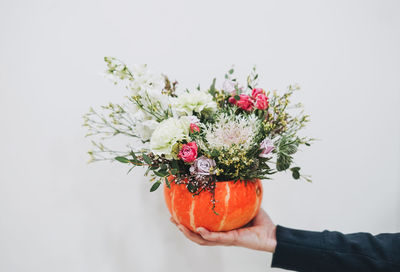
top-left (84, 57), bottom-right (313, 212)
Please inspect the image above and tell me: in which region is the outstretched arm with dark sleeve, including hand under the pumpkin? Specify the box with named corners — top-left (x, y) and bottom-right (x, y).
top-left (172, 209), bottom-right (400, 272)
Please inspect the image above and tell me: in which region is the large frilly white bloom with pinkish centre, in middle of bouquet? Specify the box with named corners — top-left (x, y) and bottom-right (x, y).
top-left (202, 114), bottom-right (261, 150)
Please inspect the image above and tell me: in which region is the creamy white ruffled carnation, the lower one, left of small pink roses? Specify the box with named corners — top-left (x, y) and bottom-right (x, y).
top-left (150, 117), bottom-right (190, 158)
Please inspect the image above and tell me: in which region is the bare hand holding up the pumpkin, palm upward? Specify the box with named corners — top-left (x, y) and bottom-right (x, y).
top-left (171, 208), bottom-right (276, 253)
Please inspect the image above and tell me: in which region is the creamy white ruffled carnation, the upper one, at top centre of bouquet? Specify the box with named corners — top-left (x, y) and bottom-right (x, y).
top-left (173, 90), bottom-right (217, 116)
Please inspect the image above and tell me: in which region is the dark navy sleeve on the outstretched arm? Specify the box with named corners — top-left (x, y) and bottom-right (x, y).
top-left (271, 225), bottom-right (400, 272)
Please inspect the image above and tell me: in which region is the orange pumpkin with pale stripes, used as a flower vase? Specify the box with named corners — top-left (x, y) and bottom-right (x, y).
top-left (164, 177), bottom-right (263, 232)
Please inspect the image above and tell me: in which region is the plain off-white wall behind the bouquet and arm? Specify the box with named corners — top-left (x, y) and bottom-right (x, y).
top-left (0, 0), bottom-right (400, 272)
